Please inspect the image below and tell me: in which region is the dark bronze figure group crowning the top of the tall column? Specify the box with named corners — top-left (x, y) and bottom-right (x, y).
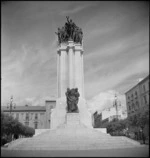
top-left (55, 16), bottom-right (83, 44)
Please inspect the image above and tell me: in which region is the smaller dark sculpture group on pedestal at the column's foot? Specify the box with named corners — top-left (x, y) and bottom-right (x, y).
top-left (66, 88), bottom-right (80, 113)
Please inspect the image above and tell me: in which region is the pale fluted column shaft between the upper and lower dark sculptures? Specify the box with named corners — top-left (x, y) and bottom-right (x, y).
top-left (57, 41), bottom-right (84, 98)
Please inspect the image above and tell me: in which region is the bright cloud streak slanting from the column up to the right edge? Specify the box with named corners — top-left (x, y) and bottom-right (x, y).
top-left (85, 52), bottom-right (149, 99)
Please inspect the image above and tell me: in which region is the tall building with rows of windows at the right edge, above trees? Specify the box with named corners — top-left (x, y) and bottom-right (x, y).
top-left (125, 75), bottom-right (149, 116)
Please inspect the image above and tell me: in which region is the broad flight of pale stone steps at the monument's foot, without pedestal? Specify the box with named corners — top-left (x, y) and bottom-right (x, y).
top-left (8, 127), bottom-right (141, 150)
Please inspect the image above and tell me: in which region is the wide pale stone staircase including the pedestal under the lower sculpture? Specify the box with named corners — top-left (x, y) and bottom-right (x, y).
top-left (8, 114), bottom-right (140, 150)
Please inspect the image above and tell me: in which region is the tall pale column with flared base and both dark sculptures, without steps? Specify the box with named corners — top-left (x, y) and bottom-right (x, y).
top-left (51, 16), bottom-right (92, 129)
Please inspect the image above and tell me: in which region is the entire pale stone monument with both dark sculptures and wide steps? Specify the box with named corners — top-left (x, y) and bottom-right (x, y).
top-left (5, 17), bottom-right (140, 154)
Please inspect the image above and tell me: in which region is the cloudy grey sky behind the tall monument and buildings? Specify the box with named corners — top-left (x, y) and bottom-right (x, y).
top-left (1, 1), bottom-right (149, 111)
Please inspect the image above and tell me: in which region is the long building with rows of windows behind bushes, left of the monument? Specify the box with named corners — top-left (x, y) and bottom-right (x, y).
top-left (1, 100), bottom-right (56, 129)
